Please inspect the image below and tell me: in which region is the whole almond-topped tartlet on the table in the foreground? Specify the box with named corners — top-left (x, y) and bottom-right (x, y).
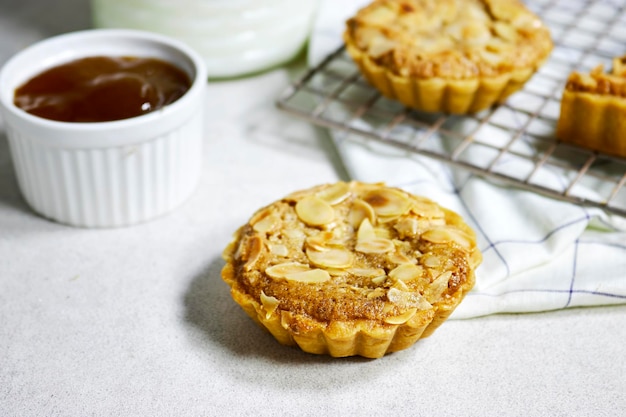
top-left (222, 182), bottom-right (482, 358)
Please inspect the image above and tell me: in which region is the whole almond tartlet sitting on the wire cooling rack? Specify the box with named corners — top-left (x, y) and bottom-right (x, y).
top-left (343, 0), bottom-right (553, 114)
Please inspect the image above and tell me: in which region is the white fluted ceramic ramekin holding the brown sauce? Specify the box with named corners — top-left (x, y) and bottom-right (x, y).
top-left (0, 29), bottom-right (207, 227)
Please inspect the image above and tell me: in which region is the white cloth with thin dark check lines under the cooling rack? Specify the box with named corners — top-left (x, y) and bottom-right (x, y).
top-left (309, 0), bottom-right (626, 319)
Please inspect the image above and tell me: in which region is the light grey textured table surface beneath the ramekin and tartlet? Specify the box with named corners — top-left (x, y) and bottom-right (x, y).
top-left (0, 0), bottom-right (626, 416)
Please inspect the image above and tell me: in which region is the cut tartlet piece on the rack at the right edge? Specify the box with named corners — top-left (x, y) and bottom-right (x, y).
top-left (556, 56), bottom-right (626, 158)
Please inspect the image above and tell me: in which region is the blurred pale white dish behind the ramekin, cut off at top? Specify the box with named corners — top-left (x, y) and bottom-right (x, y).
top-left (91, 0), bottom-right (320, 78)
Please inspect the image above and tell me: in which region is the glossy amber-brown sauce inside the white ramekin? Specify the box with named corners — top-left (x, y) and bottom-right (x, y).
top-left (14, 56), bottom-right (191, 123)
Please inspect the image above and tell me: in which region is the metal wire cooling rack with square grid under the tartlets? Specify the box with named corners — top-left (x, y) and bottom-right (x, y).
top-left (276, 0), bottom-right (626, 216)
